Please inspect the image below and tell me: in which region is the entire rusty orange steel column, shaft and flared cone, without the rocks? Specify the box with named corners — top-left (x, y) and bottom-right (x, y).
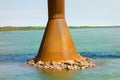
top-left (35, 0), bottom-right (82, 62)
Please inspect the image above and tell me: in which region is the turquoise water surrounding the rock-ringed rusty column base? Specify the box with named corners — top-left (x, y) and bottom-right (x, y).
top-left (0, 28), bottom-right (120, 80)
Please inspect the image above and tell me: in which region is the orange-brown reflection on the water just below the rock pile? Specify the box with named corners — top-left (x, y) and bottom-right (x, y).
top-left (38, 69), bottom-right (83, 80)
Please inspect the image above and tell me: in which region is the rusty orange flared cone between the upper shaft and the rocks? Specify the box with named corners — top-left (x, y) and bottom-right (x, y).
top-left (35, 19), bottom-right (82, 62)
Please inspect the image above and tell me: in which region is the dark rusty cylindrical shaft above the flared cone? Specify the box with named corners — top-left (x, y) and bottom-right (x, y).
top-left (48, 0), bottom-right (65, 19)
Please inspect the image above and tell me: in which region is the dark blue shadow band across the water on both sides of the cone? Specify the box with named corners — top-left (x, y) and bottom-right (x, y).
top-left (0, 51), bottom-right (120, 62)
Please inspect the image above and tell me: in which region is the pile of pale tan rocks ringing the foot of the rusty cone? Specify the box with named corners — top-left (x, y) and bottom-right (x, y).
top-left (27, 58), bottom-right (95, 70)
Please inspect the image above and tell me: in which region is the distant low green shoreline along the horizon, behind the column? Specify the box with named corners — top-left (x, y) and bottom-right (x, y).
top-left (0, 26), bottom-right (120, 32)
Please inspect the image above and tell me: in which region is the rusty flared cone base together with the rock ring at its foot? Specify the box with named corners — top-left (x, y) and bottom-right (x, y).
top-left (28, 19), bottom-right (95, 70)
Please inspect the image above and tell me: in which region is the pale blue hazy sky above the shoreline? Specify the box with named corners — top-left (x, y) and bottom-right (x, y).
top-left (0, 0), bottom-right (120, 26)
